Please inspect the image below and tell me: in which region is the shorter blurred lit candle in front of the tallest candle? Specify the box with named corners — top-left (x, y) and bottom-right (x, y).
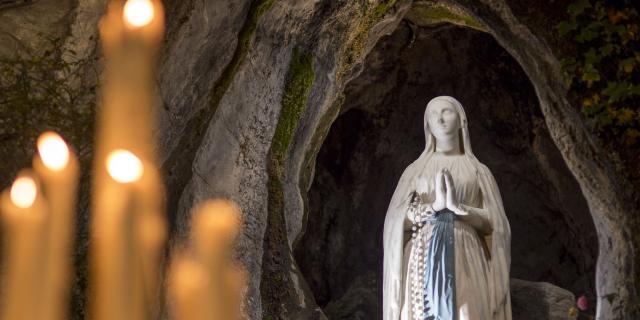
top-left (94, 149), bottom-right (166, 319)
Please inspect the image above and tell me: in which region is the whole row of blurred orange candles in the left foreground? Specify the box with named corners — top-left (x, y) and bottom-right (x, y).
top-left (0, 0), bottom-right (245, 320)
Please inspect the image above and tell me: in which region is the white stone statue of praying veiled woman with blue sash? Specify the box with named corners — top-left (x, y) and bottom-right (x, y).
top-left (383, 96), bottom-right (511, 320)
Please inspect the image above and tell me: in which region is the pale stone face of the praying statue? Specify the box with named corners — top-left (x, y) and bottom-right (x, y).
top-left (427, 100), bottom-right (460, 139)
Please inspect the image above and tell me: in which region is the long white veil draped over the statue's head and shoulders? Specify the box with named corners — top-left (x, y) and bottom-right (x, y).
top-left (382, 96), bottom-right (511, 320)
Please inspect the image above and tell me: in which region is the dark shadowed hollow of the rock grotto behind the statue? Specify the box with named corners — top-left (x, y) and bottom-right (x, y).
top-left (295, 22), bottom-right (598, 319)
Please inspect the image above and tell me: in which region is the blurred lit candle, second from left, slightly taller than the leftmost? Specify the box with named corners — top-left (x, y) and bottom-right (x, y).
top-left (33, 132), bottom-right (79, 320)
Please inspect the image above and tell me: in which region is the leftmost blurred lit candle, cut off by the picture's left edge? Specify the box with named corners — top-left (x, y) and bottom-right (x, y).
top-left (0, 170), bottom-right (47, 319)
